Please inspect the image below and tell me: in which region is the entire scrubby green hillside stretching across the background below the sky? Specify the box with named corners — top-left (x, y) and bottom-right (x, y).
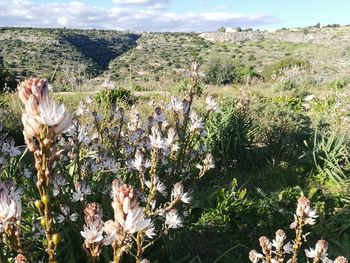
top-left (0, 26), bottom-right (350, 90)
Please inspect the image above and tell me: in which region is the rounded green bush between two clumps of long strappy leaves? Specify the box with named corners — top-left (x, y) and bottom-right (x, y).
top-left (252, 98), bottom-right (311, 164)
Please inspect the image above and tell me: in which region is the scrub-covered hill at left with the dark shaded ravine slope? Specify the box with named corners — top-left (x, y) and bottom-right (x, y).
top-left (0, 28), bottom-right (140, 89)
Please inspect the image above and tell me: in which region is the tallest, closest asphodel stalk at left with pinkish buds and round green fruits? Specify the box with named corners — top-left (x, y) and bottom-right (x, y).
top-left (18, 79), bottom-right (71, 262)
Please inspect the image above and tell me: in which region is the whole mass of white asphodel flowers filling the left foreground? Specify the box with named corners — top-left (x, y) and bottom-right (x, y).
top-left (0, 63), bottom-right (218, 262)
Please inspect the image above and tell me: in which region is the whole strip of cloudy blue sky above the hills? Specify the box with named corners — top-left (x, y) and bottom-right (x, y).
top-left (0, 0), bottom-right (350, 32)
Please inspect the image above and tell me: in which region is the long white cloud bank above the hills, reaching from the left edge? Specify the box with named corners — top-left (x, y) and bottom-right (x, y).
top-left (0, 0), bottom-right (281, 31)
